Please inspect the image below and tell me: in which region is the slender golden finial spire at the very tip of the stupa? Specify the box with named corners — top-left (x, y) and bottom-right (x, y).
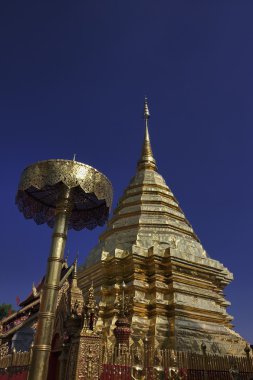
top-left (138, 97), bottom-right (157, 171)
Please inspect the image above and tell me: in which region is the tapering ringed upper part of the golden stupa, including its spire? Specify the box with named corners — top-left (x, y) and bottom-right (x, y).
top-left (86, 99), bottom-right (205, 266)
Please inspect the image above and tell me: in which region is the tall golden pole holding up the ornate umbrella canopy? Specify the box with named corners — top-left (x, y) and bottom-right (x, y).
top-left (28, 186), bottom-right (71, 380)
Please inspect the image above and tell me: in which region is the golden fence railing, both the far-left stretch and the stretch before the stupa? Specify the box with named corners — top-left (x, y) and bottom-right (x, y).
top-left (0, 345), bottom-right (253, 380)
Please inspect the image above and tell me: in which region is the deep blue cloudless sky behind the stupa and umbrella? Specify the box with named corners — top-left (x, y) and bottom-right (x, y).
top-left (0, 0), bottom-right (253, 343)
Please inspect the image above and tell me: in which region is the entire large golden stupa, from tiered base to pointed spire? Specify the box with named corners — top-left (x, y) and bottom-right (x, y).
top-left (78, 100), bottom-right (246, 355)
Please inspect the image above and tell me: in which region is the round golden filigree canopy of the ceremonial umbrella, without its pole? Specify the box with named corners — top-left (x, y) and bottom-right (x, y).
top-left (16, 159), bottom-right (112, 230)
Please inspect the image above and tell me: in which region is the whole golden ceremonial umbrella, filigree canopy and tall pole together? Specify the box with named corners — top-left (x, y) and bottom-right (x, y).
top-left (16, 160), bottom-right (112, 380)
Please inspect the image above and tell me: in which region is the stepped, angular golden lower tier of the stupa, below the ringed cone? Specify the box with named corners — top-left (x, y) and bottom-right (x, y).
top-left (78, 240), bottom-right (246, 355)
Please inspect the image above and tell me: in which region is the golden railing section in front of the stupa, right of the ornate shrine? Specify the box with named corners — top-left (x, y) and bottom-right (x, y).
top-left (102, 345), bottom-right (253, 380)
